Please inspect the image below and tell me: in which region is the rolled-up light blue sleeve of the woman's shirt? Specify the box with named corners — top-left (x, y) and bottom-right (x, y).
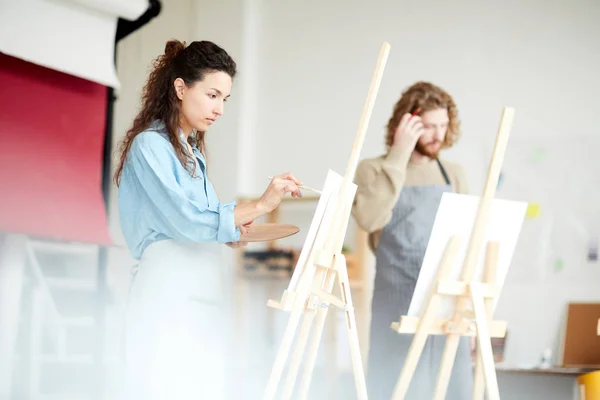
top-left (128, 135), bottom-right (240, 243)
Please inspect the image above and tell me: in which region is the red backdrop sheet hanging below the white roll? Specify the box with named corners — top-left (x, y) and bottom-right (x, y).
top-left (0, 54), bottom-right (110, 244)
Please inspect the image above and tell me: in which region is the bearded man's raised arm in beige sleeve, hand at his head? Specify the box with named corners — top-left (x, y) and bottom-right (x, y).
top-left (352, 146), bottom-right (411, 233)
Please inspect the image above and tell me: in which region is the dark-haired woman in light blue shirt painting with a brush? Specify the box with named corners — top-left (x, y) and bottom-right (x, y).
top-left (115, 41), bottom-right (301, 400)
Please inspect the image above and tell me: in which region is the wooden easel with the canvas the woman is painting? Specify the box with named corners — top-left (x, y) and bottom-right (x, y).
top-left (264, 42), bottom-right (390, 400)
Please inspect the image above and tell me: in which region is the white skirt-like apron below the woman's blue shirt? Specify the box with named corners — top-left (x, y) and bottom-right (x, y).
top-left (125, 240), bottom-right (227, 400)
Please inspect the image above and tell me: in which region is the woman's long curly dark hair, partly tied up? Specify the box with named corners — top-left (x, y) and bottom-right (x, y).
top-left (114, 40), bottom-right (236, 186)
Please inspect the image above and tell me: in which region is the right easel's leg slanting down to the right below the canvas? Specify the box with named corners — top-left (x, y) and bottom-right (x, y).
top-left (470, 284), bottom-right (500, 400)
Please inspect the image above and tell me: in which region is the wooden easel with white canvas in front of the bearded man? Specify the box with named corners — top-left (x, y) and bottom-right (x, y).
top-left (391, 107), bottom-right (527, 400)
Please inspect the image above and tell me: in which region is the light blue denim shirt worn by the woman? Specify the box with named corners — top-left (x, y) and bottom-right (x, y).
top-left (119, 121), bottom-right (240, 260)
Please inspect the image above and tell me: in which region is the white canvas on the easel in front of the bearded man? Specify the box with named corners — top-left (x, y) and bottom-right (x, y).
top-left (408, 193), bottom-right (527, 319)
